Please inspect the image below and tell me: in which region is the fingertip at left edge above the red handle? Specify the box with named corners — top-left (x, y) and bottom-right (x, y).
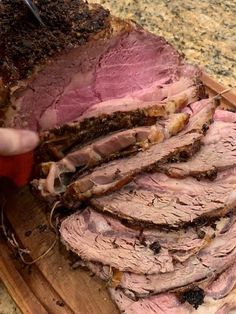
top-left (0, 128), bottom-right (39, 156)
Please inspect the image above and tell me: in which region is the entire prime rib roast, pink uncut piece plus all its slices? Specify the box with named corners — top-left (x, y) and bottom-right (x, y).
top-left (0, 0), bottom-right (236, 314)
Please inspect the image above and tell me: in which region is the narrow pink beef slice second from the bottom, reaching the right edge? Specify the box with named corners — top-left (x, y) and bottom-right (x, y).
top-left (120, 218), bottom-right (236, 296)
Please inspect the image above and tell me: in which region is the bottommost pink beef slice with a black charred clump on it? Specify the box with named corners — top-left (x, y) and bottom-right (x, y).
top-left (109, 265), bottom-right (236, 314)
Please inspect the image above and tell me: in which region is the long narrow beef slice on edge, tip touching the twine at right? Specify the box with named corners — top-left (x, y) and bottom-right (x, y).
top-left (64, 100), bottom-right (217, 207)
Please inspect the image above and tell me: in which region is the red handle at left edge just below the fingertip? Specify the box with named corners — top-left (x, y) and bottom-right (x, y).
top-left (0, 152), bottom-right (34, 186)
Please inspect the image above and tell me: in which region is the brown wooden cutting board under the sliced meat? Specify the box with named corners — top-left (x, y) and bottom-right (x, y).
top-left (0, 74), bottom-right (236, 314)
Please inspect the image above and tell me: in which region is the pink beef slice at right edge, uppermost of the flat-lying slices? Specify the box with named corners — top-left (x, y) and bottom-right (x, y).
top-left (162, 110), bottom-right (236, 179)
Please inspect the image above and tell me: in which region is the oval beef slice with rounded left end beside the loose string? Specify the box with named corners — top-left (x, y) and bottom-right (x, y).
top-left (60, 208), bottom-right (214, 274)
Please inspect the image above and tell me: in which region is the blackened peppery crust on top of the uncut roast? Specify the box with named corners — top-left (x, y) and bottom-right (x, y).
top-left (0, 0), bottom-right (110, 85)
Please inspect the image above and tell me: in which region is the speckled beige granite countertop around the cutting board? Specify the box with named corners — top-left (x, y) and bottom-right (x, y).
top-left (0, 0), bottom-right (236, 314)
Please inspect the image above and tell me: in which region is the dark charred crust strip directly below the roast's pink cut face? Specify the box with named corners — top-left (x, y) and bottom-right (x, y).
top-left (36, 110), bottom-right (159, 161)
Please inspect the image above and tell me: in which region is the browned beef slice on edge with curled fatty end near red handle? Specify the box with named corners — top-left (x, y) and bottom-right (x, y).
top-left (33, 113), bottom-right (189, 196)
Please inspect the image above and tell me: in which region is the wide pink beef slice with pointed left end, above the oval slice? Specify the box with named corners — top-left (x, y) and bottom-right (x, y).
top-left (91, 168), bottom-right (236, 228)
